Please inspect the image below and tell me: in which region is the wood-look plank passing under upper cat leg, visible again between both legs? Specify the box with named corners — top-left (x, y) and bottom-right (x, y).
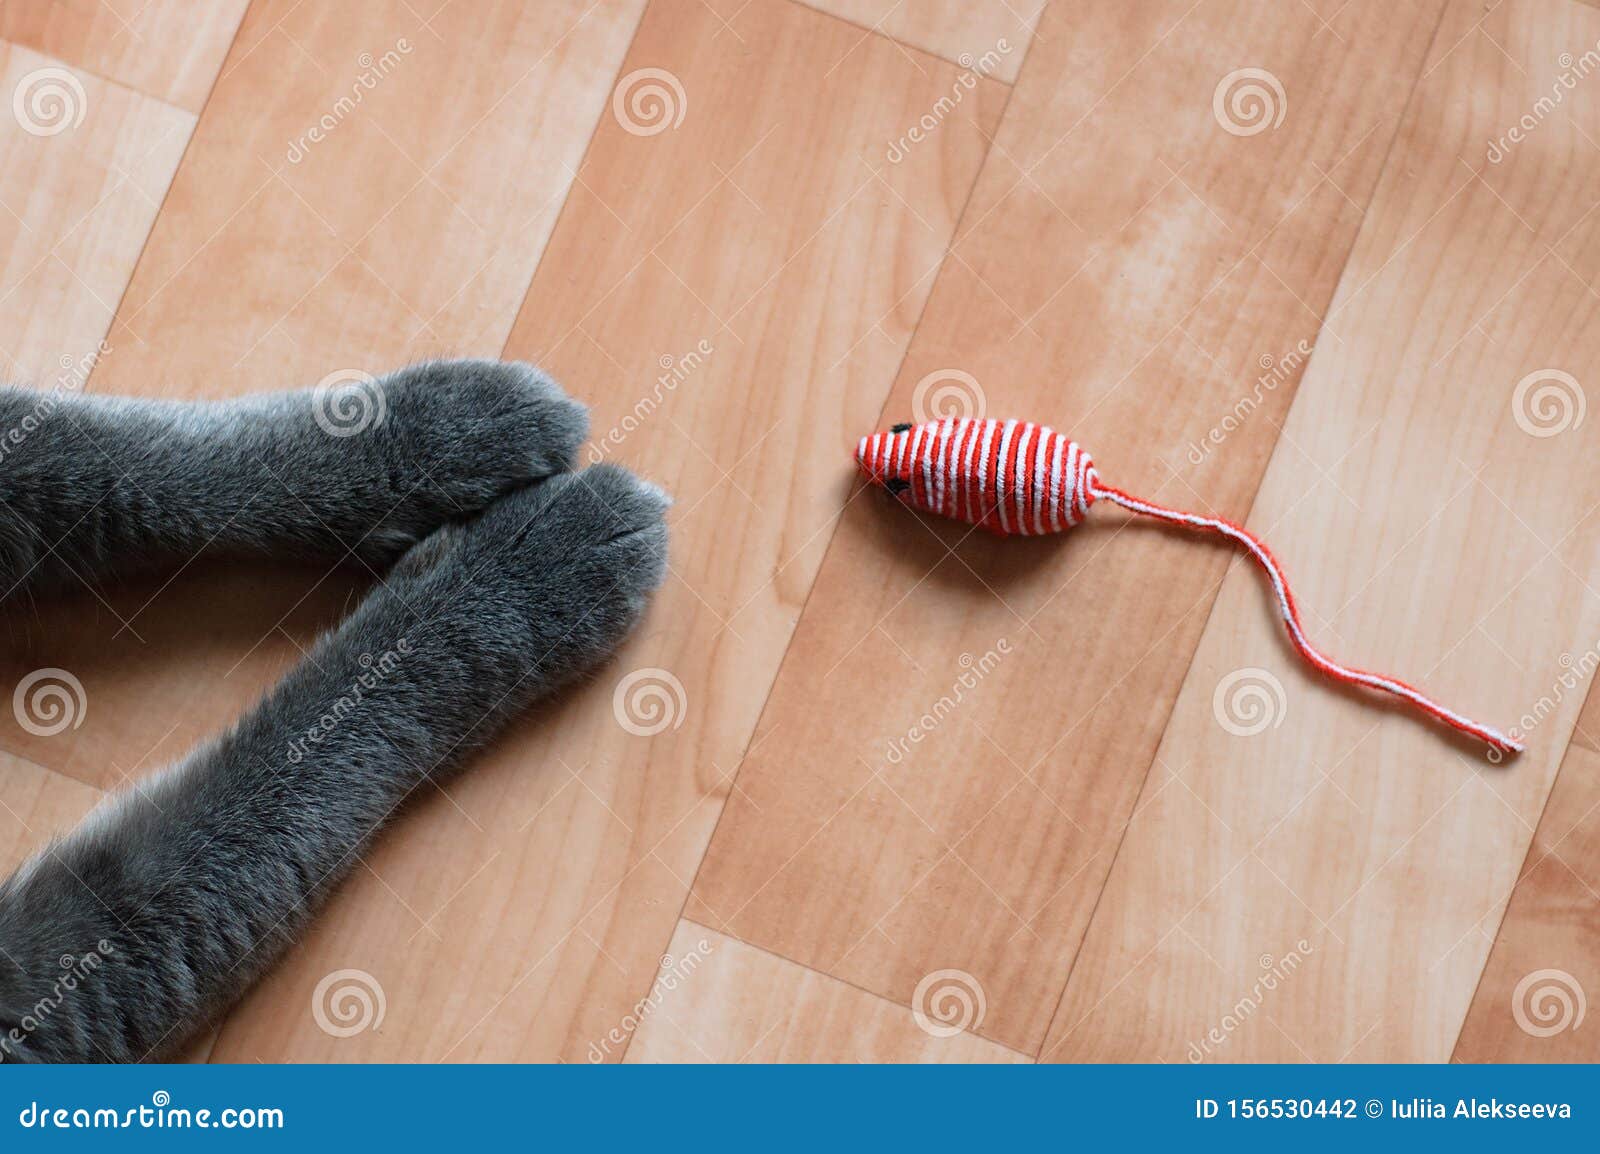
top-left (0, 0), bottom-right (643, 786)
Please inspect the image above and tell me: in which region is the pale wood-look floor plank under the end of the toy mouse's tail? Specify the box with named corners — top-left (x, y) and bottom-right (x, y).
top-left (1043, 3), bottom-right (1600, 1061)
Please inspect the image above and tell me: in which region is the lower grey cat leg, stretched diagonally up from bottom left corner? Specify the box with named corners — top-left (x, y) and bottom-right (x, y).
top-left (0, 466), bottom-right (667, 1061)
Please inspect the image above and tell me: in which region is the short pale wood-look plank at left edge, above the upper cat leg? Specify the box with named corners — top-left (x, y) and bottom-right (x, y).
top-left (0, 42), bottom-right (194, 389)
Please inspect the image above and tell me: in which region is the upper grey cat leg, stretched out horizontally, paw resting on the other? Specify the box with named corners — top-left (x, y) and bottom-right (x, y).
top-left (0, 360), bottom-right (587, 600)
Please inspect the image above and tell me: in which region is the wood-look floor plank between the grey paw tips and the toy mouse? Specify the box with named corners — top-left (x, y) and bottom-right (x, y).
top-left (200, 0), bottom-right (1003, 1061)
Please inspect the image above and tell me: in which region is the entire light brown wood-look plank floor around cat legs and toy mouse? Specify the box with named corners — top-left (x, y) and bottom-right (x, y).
top-left (0, 0), bottom-right (1600, 1061)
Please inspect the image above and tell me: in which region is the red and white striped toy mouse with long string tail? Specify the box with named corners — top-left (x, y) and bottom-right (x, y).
top-left (856, 416), bottom-right (1523, 755)
